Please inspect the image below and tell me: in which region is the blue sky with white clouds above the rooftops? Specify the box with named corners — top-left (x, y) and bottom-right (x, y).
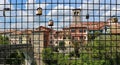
top-left (0, 0), bottom-right (120, 29)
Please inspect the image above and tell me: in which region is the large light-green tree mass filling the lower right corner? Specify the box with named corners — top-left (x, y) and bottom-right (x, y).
top-left (80, 35), bottom-right (120, 65)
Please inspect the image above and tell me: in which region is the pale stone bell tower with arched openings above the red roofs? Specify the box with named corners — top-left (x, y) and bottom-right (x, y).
top-left (72, 9), bottom-right (81, 23)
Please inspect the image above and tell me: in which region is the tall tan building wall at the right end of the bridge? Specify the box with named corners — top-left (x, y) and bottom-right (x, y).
top-left (31, 32), bottom-right (44, 65)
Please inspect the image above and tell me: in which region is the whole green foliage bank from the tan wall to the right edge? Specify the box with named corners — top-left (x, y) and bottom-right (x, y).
top-left (43, 35), bottom-right (120, 65)
